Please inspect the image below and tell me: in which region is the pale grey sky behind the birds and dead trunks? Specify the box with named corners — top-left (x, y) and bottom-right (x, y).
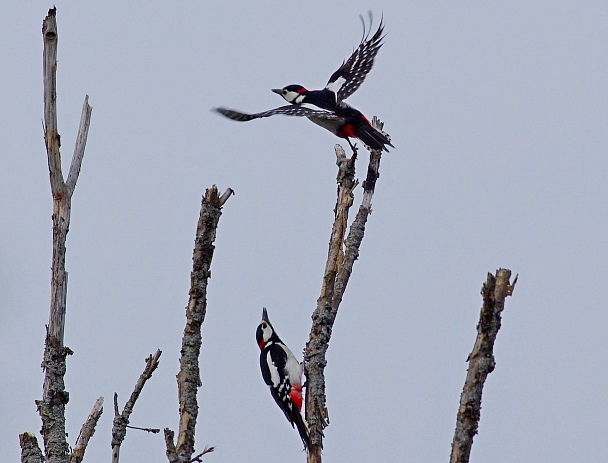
top-left (0, 0), bottom-right (608, 463)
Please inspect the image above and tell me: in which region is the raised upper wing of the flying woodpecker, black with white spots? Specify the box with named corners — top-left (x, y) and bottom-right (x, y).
top-left (325, 11), bottom-right (385, 103)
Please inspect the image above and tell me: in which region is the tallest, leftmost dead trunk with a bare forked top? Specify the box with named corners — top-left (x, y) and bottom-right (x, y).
top-left (23, 8), bottom-right (92, 463)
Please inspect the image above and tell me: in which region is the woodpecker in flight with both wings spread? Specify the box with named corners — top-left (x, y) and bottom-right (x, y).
top-left (215, 12), bottom-right (393, 151)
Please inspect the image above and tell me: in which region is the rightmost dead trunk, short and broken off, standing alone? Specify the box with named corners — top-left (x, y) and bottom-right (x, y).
top-left (450, 269), bottom-right (517, 463)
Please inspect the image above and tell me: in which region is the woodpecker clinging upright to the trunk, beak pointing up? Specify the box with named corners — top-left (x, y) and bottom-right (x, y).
top-left (255, 308), bottom-right (310, 447)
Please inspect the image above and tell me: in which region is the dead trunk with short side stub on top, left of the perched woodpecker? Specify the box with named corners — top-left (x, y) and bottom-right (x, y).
top-left (165, 185), bottom-right (234, 463)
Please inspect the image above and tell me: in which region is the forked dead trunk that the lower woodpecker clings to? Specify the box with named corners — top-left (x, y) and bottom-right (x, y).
top-left (304, 117), bottom-right (383, 463)
